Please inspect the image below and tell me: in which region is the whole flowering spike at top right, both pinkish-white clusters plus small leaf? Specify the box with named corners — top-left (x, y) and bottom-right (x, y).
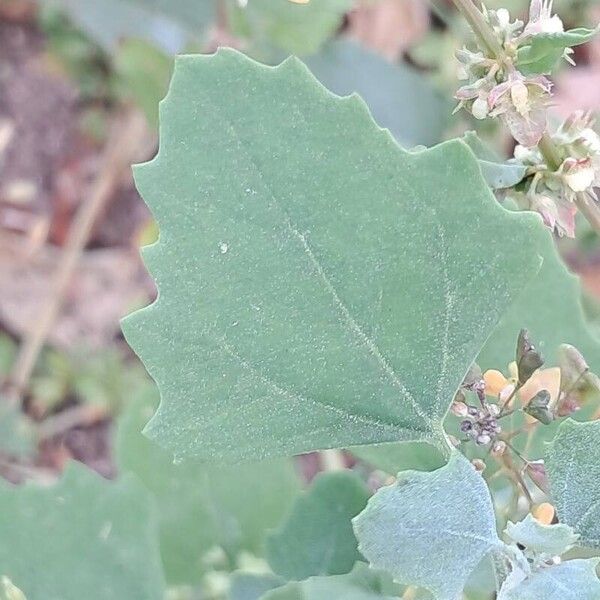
top-left (456, 0), bottom-right (600, 237)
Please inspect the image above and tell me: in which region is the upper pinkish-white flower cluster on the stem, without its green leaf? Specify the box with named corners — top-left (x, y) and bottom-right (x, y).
top-left (456, 0), bottom-right (570, 147)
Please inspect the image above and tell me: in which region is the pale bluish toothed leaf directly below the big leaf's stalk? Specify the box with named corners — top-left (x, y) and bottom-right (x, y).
top-left (354, 452), bottom-right (502, 600)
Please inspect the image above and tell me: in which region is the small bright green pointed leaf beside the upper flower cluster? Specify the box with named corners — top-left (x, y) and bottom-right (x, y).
top-left (517, 27), bottom-right (598, 75)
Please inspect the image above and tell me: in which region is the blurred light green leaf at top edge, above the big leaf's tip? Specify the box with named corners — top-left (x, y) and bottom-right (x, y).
top-left (226, 0), bottom-right (353, 58)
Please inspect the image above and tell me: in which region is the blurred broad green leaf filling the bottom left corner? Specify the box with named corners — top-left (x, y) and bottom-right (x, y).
top-left (0, 463), bottom-right (165, 600)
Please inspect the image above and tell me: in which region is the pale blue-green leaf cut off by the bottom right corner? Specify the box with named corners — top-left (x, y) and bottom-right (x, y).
top-left (498, 558), bottom-right (600, 600)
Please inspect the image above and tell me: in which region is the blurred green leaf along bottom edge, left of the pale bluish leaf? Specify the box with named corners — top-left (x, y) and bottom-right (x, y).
top-left (261, 563), bottom-right (400, 600)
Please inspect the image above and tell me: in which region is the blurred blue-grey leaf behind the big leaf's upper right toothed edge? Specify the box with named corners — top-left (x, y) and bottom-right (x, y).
top-left (306, 40), bottom-right (451, 147)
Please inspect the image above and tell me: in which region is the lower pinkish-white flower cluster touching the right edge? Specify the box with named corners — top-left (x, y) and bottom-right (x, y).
top-left (509, 112), bottom-right (600, 237)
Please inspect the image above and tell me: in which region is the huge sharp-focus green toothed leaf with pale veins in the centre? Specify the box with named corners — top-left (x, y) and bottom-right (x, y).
top-left (123, 50), bottom-right (541, 461)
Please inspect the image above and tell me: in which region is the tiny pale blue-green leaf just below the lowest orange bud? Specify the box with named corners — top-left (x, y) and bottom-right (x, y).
top-left (506, 514), bottom-right (579, 556)
